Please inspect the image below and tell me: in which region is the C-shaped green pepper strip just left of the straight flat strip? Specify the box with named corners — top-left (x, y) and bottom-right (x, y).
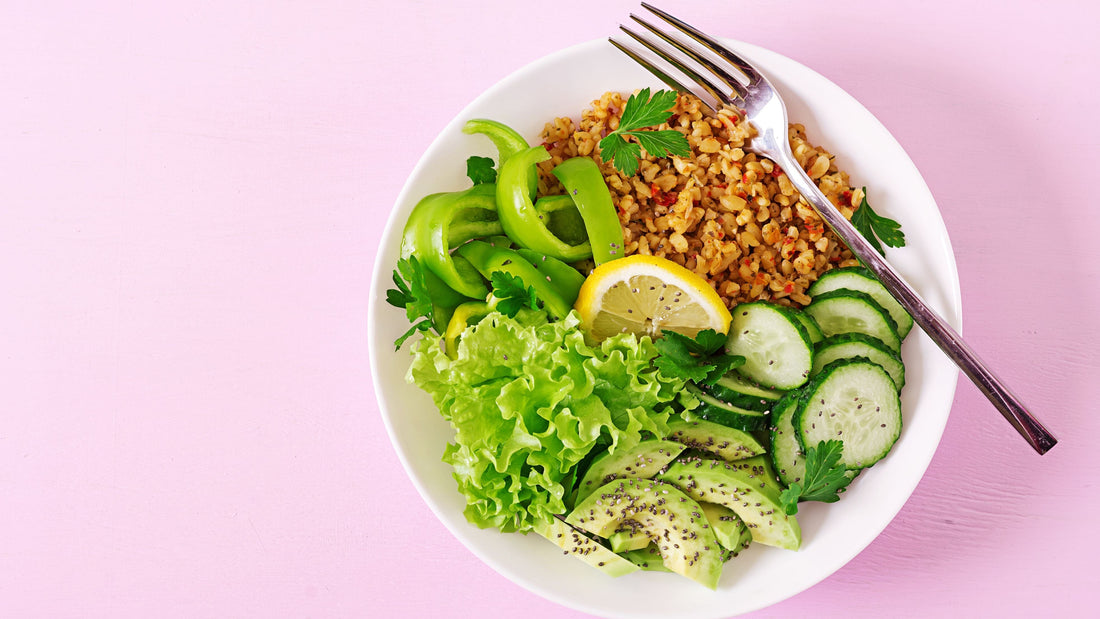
top-left (496, 146), bottom-right (594, 263)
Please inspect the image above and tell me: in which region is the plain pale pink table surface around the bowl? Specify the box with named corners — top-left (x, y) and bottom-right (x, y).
top-left (0, 0), bottom-right (1100, 618)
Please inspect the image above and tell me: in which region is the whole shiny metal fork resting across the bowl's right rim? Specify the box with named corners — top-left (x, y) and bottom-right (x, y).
top-left (609, 2), bottom-right (1057, 454)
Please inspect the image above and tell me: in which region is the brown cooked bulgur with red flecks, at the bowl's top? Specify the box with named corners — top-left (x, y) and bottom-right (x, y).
top-left (539, 92), bottom-right (862, 307)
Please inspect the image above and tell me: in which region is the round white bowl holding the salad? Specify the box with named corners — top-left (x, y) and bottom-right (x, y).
top-left (369, 41), bottom-right (961, 619)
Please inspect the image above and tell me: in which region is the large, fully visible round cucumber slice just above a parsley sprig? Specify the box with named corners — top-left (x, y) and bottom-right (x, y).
top-left (793, 358), bottom-right (901, 469)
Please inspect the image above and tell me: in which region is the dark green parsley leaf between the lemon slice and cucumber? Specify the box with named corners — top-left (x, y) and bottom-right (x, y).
top-left (653, 329), bottom-right (745, 385)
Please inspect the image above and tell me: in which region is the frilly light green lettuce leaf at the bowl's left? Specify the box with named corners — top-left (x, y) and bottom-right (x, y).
top-left (407, 312), bottom-right (684, 531)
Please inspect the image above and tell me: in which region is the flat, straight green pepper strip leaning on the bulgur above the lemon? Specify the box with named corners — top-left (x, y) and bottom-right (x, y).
top-left (553, 157), bottom-right (623, 266)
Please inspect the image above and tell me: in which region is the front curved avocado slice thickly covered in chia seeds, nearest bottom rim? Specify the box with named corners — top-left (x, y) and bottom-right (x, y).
top-left (565, 478), bottom-right (723, 589)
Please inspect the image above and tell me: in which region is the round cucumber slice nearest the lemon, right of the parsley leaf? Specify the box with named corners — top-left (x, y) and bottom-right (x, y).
top-left (726, 301), bottom-right (813, 390)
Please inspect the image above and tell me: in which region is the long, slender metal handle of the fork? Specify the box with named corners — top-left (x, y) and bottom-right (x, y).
top-left (778, 156), bottom-right (1058, 454)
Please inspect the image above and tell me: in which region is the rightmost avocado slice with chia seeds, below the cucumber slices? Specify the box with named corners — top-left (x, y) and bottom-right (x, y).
top-left (657, 455), bottom-right (802, 550)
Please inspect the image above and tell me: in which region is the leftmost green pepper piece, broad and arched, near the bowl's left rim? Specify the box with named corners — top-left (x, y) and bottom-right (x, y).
top-left (402, 185), bottom-right (503, 299)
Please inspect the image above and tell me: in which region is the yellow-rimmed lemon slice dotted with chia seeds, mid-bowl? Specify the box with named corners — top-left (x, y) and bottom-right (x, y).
top-left (574, 254), bottom-right (732, 341)
